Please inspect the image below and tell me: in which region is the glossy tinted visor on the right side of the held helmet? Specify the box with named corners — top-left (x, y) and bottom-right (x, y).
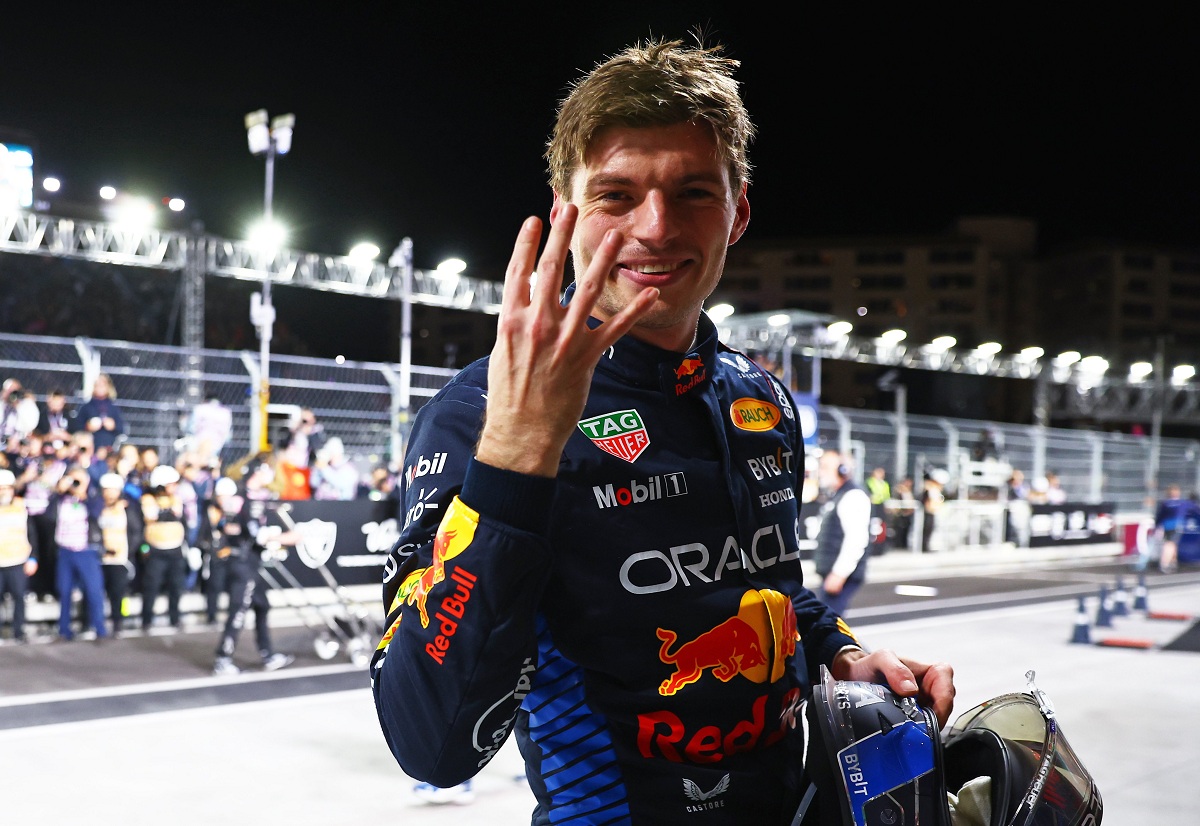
top-left (946, 675), bottom-right (1103, 826)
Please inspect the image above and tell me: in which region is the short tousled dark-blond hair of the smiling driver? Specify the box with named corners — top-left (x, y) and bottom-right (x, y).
top-left (546, 40), bottom-right (755, 198)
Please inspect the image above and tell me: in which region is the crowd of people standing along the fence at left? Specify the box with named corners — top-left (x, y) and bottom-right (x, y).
top-left (0, 373), bottom-right (396, 653)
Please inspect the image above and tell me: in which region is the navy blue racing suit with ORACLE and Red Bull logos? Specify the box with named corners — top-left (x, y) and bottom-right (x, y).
top-left (371, 317), bottom-right (856, 825)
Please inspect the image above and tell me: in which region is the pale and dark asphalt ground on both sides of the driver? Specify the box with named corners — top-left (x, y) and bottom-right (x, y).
top-left (0, 549), bottom-right (1200, 826)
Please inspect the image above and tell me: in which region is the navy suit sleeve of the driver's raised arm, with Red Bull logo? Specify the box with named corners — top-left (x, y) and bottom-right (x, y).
top-left (371, 391), bottom-right (556, 786)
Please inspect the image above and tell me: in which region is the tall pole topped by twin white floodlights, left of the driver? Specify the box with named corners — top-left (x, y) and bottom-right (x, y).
top-left (244, 109), bottom-right (296, 451)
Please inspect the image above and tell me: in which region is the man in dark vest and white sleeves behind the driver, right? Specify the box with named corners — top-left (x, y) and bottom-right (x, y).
top-left (814, 450), bottom-right (871, 616)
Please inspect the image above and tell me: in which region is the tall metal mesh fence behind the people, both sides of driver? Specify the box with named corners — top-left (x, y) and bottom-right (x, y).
top-left (0, 326), bottom-right (1200, 513)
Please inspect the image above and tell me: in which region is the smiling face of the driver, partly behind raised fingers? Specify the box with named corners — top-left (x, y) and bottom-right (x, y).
top-left (551, 124), bottom-right (750, 351)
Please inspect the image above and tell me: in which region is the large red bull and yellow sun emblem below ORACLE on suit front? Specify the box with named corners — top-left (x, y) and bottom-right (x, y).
top-left (656, 589), bottom-right (796, 696)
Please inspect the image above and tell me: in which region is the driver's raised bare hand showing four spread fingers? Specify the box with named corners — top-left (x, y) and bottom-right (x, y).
top-left (475, 204), bottom-right (659, 477)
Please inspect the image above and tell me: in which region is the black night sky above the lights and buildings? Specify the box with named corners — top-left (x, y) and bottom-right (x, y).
top-left (0, 1), bottom-right (1200, 277)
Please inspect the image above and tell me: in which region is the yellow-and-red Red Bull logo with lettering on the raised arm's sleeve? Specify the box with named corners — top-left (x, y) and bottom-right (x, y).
top-left (396, 498), bottom-right (479, 665)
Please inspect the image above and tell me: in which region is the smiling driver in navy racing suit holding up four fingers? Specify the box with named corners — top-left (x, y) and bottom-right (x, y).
top-left (372, 43), bottom-right (953, 824)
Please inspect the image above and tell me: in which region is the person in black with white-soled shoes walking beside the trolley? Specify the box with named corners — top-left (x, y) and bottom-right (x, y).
top-left (212, 457), bottom-right (299, 677)
